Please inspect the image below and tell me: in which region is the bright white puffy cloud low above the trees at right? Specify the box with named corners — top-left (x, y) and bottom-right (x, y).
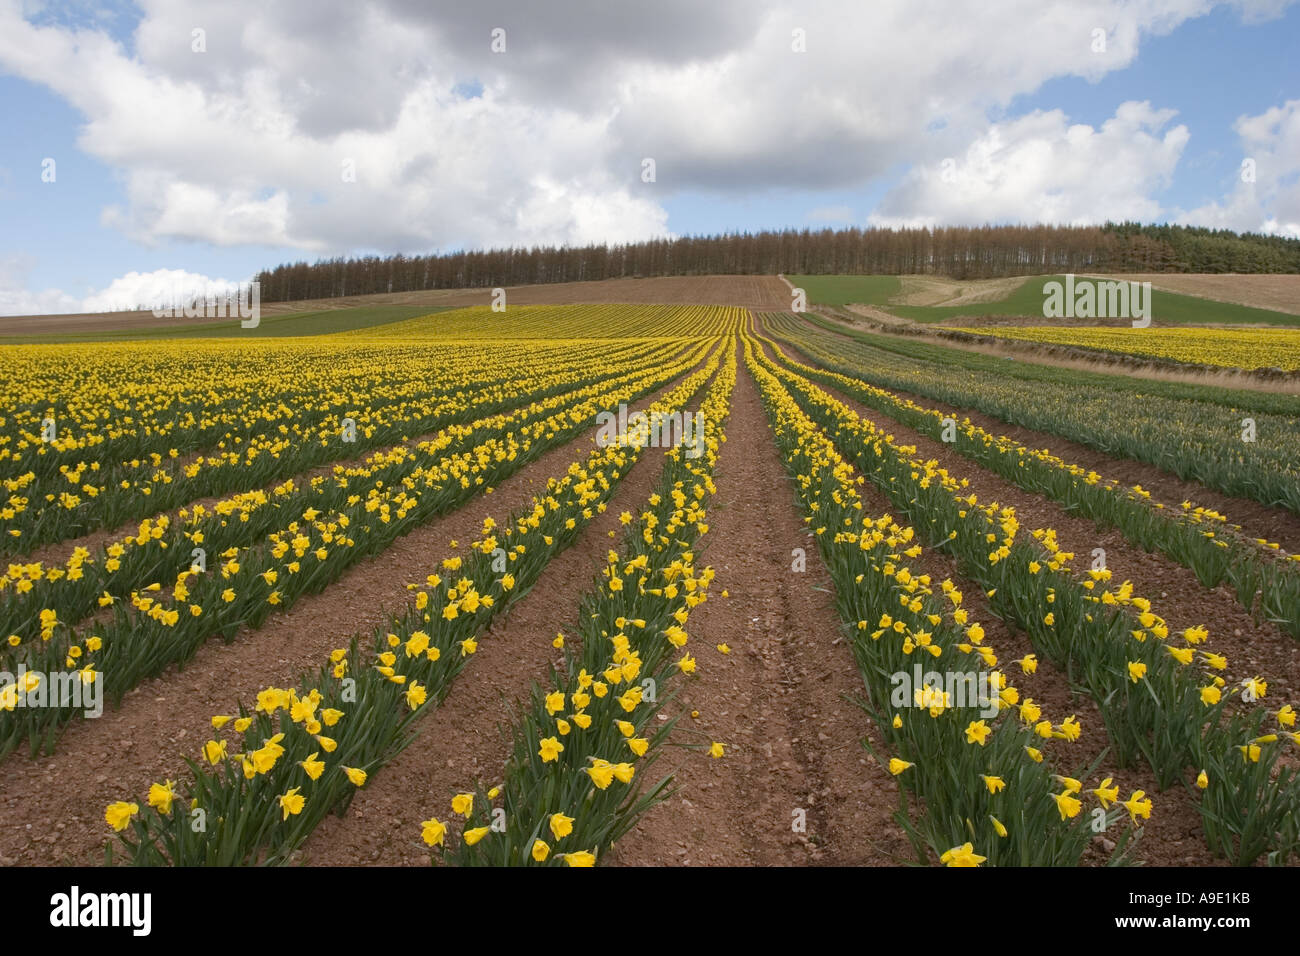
top-left (870, 103), bottom-right (1188, 226)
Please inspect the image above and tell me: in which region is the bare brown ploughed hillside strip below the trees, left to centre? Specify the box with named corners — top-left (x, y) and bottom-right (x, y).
top-left (0, 276), bottom-right (790, 336)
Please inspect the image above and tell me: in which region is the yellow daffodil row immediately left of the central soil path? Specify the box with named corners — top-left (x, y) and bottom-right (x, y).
top-left (423, 339), bottom-right (736, 866)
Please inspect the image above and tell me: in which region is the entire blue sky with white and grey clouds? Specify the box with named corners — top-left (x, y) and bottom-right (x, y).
top-left (0, 0), bottom-right (1300, 315)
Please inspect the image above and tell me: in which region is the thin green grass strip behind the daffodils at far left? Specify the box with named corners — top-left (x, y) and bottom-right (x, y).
top-left (0, 306), bottom-right (446, 345)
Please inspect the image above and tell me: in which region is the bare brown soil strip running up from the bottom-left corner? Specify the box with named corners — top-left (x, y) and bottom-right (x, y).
top-left (0, 364), bottom-right (702, 866)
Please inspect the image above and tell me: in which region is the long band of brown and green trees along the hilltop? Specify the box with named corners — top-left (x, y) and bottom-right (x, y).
top-left (250, 222), bottom-right (1300, 302)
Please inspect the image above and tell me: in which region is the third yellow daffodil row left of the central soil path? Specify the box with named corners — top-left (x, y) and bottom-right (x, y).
top-left (0, 345), bottom-right (707, 754)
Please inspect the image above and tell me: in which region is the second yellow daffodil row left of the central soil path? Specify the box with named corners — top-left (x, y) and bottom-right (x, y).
top-left (98, 338), bottom-right (719, 865)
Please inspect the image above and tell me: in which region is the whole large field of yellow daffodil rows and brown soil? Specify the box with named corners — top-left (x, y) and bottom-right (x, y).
top-left (0, 303), bottom-right (1300, 866)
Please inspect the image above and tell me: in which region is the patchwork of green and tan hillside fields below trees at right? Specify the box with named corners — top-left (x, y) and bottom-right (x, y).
top-left (787, 274), bottom-right (1300, 328)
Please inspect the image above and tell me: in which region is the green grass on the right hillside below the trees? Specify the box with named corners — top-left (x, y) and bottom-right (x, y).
top-left (787, 276), bottom-right (1300, 328)
